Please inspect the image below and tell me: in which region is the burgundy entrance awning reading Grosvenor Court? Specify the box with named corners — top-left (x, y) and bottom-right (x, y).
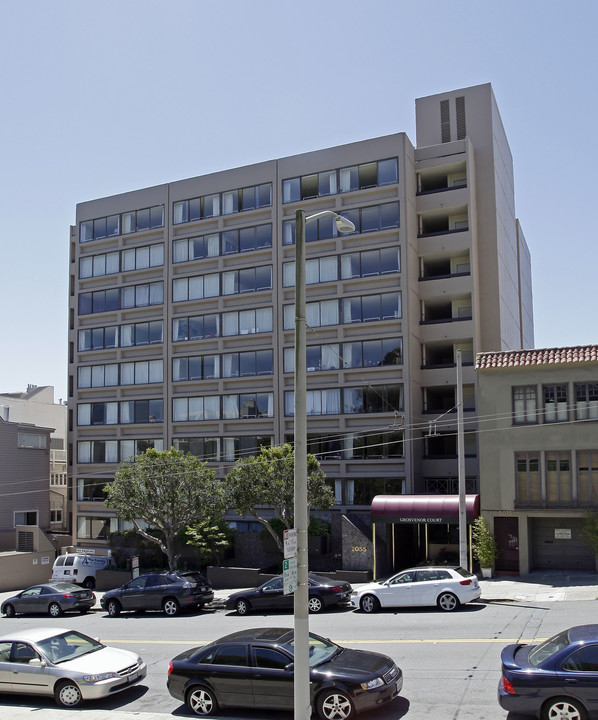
top-left (370, 495), bottom-right (480, 524)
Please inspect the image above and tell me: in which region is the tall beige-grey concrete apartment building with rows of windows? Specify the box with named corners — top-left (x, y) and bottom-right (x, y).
top-left (69, 84), bottom-right (533, 568)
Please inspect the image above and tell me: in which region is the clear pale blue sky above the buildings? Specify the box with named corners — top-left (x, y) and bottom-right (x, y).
top-left (0, 0), bottom-right (598, 399)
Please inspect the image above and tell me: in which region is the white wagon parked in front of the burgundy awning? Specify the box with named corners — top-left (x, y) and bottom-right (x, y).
top-left (351, 566), bottom-right (482, 613)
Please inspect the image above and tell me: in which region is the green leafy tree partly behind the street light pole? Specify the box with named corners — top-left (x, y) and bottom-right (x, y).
top-left (225, 445), bottom-right (335, 552)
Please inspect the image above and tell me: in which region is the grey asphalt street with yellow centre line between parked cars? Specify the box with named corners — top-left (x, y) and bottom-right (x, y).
top-left (0, 573), bottom-right (598, 720)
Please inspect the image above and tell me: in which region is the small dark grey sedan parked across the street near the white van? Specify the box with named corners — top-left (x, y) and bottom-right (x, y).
top-left (0, 582), bottom-right (96, 617)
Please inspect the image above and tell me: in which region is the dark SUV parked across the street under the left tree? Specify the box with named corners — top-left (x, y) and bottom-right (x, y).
top-left (100, 572), bottom-right (214, 617)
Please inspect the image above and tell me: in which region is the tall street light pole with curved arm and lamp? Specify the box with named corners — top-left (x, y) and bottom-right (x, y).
top-left (293, 205), bottom-right (355, 720)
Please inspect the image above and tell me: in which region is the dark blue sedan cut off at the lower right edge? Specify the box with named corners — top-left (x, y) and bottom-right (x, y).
top-left (498, 625), bottom-right (598, 720)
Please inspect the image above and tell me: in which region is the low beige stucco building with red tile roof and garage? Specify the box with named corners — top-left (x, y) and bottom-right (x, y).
top-left (476, 345), bottom-right (598, 573)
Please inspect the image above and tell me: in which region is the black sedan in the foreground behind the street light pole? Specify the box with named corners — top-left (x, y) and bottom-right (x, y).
top-left (167, 628), bottom-right (403, 720)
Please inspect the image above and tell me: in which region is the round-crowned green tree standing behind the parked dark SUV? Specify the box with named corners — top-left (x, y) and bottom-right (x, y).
top-left (106, 448), bottom-right (224, 570)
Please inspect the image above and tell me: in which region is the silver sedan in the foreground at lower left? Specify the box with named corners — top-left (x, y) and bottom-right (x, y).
top-left (0, 628), bottom-right (147, 708)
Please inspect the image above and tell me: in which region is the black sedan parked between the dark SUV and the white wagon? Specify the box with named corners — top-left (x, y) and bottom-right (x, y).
top-left (226, 573), bottom-right (353, 615)
